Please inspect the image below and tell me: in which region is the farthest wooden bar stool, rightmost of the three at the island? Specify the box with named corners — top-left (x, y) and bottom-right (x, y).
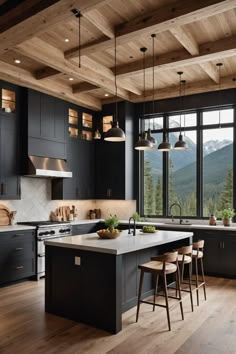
top-left (192, 240), bottom-right (206, 306)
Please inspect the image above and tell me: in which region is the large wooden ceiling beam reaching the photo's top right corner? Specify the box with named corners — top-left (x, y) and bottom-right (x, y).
top-left (66, 0), bottom-right (235, 58)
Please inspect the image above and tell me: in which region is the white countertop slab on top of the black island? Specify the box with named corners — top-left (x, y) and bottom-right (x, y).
top-left (45, 230), bottom-right (193, 255)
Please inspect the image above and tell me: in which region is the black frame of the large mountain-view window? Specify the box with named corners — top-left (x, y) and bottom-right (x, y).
top-left (138, 104), bottom-right (236, 220)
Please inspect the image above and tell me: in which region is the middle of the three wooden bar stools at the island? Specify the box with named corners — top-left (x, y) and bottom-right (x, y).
top-left (177, 245), bottom-right (193, 311)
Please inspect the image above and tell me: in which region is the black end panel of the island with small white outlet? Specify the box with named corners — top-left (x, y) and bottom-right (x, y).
top-left (45, 246), bottom-right (122, 333)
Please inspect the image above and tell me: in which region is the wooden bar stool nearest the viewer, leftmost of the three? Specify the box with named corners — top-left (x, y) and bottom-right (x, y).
top-left (136, 252), bottom-right (184, 331)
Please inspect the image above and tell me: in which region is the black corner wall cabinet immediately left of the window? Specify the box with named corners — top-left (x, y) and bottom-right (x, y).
top-left (95, 102), bottom-right (134, 199)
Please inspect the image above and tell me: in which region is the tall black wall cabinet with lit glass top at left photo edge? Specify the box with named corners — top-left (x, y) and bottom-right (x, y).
top-left (0, 81), bottom-right (20, 199)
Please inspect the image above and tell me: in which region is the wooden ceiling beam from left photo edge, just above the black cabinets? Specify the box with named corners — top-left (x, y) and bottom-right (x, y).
top-left (0, 61), bottom-right (102, 111)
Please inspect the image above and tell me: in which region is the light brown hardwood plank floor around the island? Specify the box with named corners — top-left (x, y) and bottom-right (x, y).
top-left (0, 277), bottom-right (236, 354)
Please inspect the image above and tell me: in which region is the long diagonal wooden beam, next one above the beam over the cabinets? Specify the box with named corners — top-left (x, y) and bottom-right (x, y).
top-left (14, 38), bottom-right (129, 100)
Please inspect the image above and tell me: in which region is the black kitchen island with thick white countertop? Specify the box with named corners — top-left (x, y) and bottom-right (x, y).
top-left (45, 230), bottom-right (193, 333)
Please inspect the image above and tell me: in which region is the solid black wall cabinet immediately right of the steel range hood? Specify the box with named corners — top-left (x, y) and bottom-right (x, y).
top-left (52, 138), bottom-right (94, 200)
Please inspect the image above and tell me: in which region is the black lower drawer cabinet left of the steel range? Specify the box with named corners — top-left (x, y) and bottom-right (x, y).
top-left (0, 230), bottom-right (36, 285)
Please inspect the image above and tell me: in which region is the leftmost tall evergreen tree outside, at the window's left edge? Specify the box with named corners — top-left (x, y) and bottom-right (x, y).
top-left (144, 160), bottom-right (155, 215)
